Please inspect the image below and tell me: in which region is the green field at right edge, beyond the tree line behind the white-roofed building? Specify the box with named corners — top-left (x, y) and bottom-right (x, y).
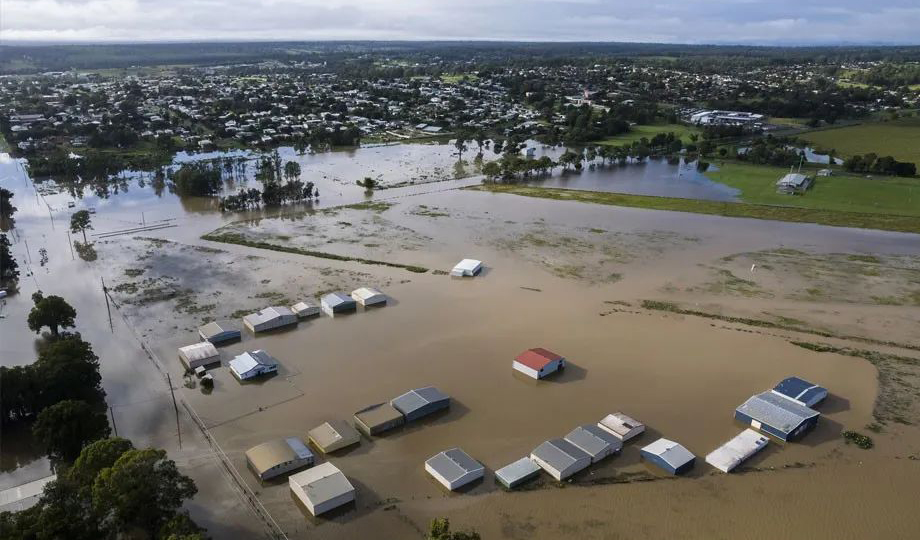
top-left (800, 116), bottom-right (920, 167)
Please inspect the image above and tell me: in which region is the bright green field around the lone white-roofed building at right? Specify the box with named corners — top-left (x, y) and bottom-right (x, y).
top-left (706, 162), bottom-right (920, 217)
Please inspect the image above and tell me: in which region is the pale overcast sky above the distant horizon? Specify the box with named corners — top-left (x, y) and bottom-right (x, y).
top-left (0, 0), bottom-right (920, 44)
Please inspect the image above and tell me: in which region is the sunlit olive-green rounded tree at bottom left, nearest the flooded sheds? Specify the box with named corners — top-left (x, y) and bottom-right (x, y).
top-left (93, 448), bottom-right (198, 535)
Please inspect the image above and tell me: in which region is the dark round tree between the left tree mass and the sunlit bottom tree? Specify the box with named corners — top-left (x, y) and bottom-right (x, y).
top-left (32, 399), bottom-right (109, 462)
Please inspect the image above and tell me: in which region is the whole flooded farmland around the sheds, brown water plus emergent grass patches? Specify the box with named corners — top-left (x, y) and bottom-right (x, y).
top-left (0, 144), bottom-right (920, 538)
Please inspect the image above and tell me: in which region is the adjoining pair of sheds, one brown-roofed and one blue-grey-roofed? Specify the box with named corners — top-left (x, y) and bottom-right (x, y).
top-left (354, 386), bottom-right (450, 437)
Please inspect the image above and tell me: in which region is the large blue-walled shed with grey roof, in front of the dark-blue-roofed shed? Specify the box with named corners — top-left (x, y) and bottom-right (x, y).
top-left (735, 390), bottom-right (821, 441)
